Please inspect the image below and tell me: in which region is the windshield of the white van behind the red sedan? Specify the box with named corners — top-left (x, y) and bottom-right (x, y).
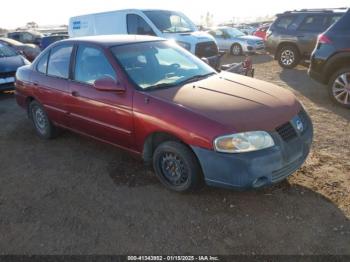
top-left (144, 11), bottom-right (196, 33)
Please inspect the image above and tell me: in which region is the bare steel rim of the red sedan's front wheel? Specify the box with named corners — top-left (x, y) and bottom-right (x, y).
top-left (159, 152), bottom-right (189, 187)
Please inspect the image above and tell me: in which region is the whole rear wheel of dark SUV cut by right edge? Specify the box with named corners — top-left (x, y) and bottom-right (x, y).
top-left (328, 67), bottom-right (350, 109)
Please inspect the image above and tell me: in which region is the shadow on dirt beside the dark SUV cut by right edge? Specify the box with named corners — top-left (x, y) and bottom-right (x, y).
top-left (279, 66), bottom-right (350, 121)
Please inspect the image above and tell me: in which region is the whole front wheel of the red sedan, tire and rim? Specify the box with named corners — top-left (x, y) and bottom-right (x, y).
top-left (153, 141), bottom-right (203, 192)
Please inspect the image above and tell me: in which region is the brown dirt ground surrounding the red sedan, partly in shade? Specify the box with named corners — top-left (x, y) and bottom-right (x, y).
top-left (0, 55), bottom-right (350, 254)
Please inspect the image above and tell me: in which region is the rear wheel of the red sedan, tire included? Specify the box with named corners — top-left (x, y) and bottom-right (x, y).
top-left (29, 101), bottom-right (58, 139)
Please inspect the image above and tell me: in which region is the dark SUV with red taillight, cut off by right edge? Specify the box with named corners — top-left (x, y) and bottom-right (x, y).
top-left (308, 10), bottom-right (350, 108)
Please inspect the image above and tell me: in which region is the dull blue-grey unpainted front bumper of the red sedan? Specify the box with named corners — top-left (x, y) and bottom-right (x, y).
top-left (192, 109), bottom-right (313, 189)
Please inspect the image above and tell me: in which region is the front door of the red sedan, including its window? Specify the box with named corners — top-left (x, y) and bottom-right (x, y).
top-left (68, 44), bottom-right (133, 148)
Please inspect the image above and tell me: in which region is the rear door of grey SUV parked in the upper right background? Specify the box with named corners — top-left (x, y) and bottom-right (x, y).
top-left (297, 14), bottom-right (329, 56)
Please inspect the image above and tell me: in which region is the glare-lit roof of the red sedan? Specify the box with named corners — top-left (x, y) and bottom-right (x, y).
top-left (60, 35), bottom-right (165, 47)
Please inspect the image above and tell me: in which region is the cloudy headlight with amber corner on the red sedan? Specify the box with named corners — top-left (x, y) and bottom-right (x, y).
top-left (214, 131), bottom-right (275, 153)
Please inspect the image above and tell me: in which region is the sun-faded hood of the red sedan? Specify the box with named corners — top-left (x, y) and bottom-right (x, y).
top-left (151, 72), bottom-right (301, 132)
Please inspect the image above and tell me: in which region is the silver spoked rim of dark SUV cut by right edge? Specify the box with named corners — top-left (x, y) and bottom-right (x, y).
top-left (332, 72), bottom-right (350, 106)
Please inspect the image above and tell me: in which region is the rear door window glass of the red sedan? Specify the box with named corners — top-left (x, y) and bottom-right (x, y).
top-left (47, 45), bottom-right (73, 78)
